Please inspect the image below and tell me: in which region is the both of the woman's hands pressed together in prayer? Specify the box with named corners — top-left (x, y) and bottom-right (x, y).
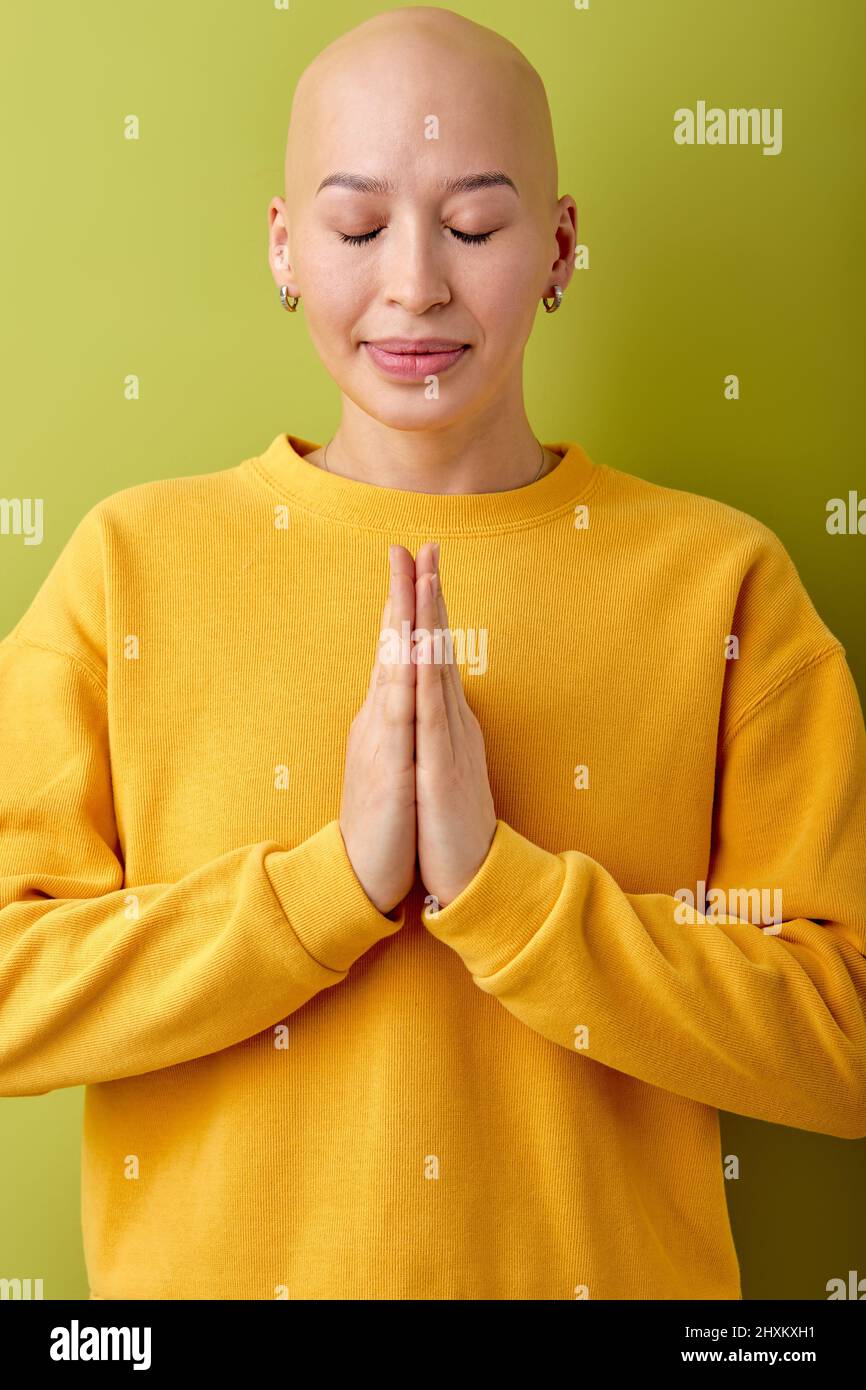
top-left (339, 542), bottom-right (496, 913)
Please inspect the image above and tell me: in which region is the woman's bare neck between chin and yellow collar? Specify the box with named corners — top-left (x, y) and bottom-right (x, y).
top-left (318, 398), bottom-right (559, 493)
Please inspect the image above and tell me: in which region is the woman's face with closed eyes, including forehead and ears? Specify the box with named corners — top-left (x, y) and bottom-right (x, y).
top-left (270, 31), bottom-right (575, 430)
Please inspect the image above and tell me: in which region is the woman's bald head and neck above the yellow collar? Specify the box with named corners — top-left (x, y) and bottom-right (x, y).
top-left (268, 6), bottom-right (577, 493)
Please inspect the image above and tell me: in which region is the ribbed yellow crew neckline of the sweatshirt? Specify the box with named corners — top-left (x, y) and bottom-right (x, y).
top-left (249, 432), bottom-right (605, 539)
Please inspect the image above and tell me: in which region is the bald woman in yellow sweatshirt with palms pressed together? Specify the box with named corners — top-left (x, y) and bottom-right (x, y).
top-left (0, 7), bottom-right (866, 1300)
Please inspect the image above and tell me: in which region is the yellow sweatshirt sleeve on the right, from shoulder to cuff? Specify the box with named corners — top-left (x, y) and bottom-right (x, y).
top-left (427, 641), bottom-right (866, 1138)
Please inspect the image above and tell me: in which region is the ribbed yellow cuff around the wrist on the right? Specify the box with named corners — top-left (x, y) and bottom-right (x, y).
top-left (423, 820), bottom-right (566, 979)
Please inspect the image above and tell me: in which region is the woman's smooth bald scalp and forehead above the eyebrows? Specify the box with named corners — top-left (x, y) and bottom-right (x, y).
top-left (285, 6), bottom-right (557, 220)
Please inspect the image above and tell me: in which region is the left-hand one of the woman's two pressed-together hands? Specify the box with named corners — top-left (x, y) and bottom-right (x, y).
top-left (339, 545), bottom-right (417, 913)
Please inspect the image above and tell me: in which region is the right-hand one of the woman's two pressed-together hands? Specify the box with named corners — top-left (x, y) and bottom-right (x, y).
top-left (414, 542), bottom-right (496, 909)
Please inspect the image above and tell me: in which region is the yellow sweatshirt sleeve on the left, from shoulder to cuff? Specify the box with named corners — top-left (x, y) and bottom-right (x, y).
top-left (0, 514), bottom-right (406, 1095)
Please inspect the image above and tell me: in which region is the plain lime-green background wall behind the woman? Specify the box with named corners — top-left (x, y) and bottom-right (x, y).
top-left (0, 0), bottom-right (866, 1298)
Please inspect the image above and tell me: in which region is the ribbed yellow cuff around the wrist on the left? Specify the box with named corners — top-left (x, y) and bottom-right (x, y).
top-left (264, 820), bottom-right (406, 973)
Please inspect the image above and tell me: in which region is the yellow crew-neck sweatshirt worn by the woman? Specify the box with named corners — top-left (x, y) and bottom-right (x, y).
top-left (0, 434), bottom-right (866, 1300)
